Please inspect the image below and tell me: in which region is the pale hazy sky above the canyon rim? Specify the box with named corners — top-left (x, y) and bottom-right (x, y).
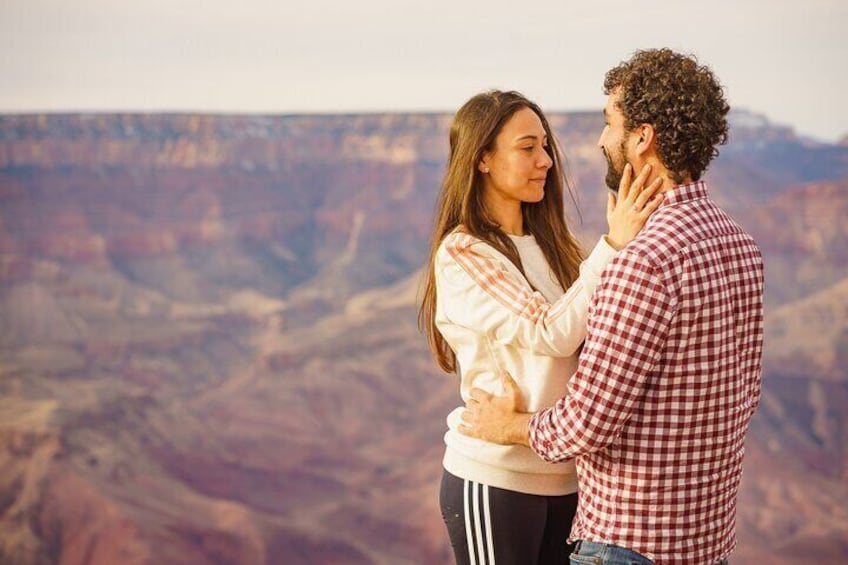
top-left (0, 0), bottom-right (848, 141)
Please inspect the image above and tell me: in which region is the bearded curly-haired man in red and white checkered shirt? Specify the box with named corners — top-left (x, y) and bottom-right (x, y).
top-left (460, 49), bottom-right (763, 565)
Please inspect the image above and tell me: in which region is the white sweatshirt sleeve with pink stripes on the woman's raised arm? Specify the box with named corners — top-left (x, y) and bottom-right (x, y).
top-left (436, 233), bottom-right (616, 357)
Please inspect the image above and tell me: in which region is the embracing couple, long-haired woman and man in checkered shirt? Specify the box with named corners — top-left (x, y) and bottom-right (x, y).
top-left (419, 49), bottom-right (763, 565)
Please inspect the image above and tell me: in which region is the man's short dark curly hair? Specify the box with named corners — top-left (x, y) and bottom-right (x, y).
top-left (604, 49), bottom-right (730, 182)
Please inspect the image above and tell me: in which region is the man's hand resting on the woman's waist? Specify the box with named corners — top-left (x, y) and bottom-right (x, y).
top-left (459, 373), bottom-right (533, 446)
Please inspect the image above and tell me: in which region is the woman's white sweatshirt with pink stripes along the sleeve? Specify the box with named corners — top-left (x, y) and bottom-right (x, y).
top-left (435, 230), bottom-right (616, 495)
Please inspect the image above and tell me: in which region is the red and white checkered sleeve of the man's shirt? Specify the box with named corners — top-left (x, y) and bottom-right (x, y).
top-left (529, 252), bottom-right (675, 462)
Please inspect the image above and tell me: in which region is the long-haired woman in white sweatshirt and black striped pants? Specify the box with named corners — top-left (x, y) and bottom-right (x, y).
top-left (419, 91), bottom-right (661, 565)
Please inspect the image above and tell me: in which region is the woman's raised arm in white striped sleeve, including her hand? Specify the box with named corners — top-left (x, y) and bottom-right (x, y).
top-left (436, 164), bottom-right (662, 357)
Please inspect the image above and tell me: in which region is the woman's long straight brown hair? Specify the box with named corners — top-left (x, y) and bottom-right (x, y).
top-left (418, 90), bottom-right (583, 373)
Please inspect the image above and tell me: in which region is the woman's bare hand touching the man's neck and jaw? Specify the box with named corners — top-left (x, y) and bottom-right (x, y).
top-left (607, 163), bottom-right (663, 250)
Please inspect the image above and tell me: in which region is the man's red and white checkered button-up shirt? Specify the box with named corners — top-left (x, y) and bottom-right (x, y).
top-left (530, 182), bottom-right (763, 565)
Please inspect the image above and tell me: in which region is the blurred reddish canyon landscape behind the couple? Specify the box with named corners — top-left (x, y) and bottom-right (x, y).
top-left (0, 111), bottom-right (848, 565)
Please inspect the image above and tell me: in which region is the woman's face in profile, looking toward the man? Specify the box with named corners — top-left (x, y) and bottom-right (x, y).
top-left (478, 108), bottom-right (553, 203)
